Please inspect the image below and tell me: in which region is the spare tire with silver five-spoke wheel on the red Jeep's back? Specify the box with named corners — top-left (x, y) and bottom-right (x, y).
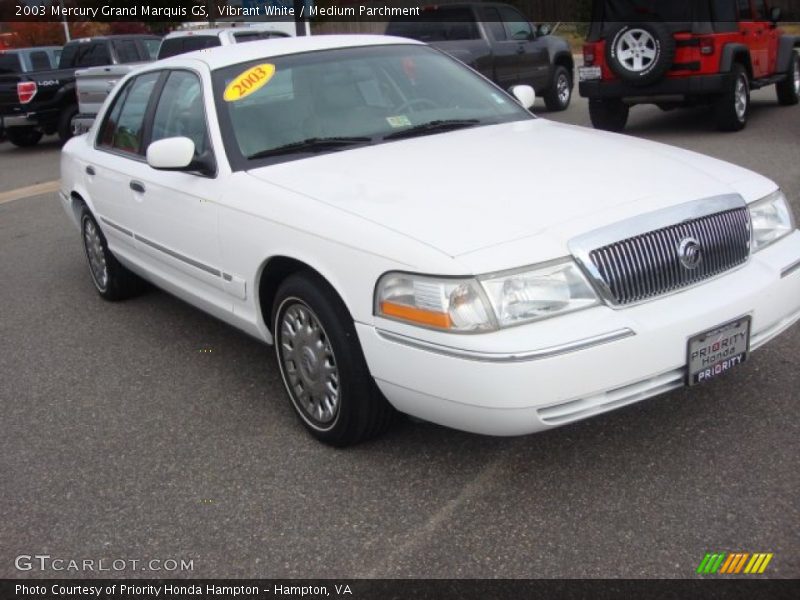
top-left (606, 23), bottom-right (675, 85)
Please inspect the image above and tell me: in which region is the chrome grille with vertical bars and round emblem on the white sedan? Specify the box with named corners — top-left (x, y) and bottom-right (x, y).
top-left (589, 207), bottom-right (750, 304)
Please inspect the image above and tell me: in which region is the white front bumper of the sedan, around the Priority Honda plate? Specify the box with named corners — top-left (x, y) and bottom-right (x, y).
top-left (356, 231), bottom-right (800, 435)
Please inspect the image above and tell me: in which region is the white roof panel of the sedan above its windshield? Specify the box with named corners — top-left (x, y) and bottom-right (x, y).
top-left (153, 35), bottom-right (424, 71)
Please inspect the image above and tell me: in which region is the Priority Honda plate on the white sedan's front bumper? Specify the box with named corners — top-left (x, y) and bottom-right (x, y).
top-left (688, 316), bottom-right (751, 385)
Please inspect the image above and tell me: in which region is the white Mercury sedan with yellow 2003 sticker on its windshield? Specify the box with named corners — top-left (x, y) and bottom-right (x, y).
top-left (62, 36), bottom-right (800, 445)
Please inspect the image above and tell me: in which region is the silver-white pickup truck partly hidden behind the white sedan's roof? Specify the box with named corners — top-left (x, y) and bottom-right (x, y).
top-left (72, 21), bottom-right (295, 135)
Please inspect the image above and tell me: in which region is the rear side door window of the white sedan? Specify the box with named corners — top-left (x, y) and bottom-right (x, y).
top-left (98, 71), bottom-right (161, 155)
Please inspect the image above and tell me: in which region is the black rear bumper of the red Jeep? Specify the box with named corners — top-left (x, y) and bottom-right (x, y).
top-left (579, 73), bottom-right (730, 103)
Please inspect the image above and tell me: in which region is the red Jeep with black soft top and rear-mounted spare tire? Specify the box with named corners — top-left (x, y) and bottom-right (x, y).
top-left (578, 0), bottom-right (800, 131)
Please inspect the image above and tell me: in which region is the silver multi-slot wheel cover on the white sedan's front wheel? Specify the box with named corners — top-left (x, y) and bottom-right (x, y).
top-left (276, 298), bottom-right (340, 430)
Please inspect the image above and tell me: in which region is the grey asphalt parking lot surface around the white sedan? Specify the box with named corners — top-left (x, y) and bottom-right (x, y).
top-left (0, 89), bottom-right (800, 577)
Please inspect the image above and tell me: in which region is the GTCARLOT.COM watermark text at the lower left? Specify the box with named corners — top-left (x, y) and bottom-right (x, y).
top-left (14, 554), bottom-right (194, 573)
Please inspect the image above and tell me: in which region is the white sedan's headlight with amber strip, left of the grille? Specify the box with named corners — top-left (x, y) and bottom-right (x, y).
top-left (375, 259), bottom-right (598, 333)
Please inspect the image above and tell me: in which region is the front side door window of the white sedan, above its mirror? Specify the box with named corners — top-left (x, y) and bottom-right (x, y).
top-left (150, 71), bottom-right (208, 155)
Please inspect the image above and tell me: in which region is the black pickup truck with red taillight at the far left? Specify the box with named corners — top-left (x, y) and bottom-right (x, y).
top-left (0, 35), bottom-right (160, 146)
